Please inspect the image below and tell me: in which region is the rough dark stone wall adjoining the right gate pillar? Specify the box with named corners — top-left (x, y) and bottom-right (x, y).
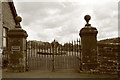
top-left (98, 44), bottom-right (120, 73)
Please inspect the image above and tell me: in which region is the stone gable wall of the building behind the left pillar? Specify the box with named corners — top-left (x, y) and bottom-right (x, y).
top-left (0, 2), bottom-right (15, 48)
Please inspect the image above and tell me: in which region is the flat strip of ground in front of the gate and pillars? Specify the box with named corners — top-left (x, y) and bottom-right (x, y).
top-left (2, 69), bottom-right (118, 78)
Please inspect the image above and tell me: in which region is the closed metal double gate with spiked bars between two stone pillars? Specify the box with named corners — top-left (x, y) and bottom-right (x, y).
top-left (27, 40), bottom-right (81, 71)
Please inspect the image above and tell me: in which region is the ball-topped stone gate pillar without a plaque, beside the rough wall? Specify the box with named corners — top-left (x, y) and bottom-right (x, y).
top-left (79, 15), bottom-right (98, 71)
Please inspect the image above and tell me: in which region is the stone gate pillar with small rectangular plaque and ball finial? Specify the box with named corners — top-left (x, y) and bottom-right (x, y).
top-left (8, 16), bottom-right (28, 72)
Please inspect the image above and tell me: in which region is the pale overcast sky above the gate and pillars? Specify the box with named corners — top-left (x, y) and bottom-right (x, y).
top-left (14, 0), bottom-right (118, 43)
